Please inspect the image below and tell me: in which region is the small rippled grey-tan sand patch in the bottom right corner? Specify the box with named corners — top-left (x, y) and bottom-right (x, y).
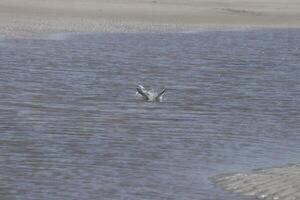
top-left (216, 165), bottom-right (300, 200)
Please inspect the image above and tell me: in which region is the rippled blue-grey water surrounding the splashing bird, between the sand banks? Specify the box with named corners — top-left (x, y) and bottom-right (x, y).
top-left (0, 29), bottom-right (300, 200)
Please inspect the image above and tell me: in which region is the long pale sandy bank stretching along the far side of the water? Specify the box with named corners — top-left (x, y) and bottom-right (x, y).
top-left (0, 0), bottom-right (300, 37)
